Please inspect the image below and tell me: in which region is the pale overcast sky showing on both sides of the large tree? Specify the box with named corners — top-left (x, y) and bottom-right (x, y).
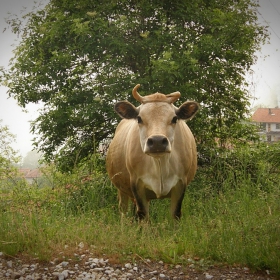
top-left (0, 0), bottom-right (280, 156)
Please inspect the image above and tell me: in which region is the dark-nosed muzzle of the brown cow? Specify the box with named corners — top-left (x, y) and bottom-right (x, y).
top-left (144, 135), bottom-right (171, 155)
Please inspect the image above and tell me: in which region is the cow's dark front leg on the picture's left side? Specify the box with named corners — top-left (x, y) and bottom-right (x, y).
top-left (131, 184), bottom-right (149, 220)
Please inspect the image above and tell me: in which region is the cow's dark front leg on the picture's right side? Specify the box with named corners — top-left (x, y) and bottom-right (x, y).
top-left (171, 183), bottom-right (186, 220)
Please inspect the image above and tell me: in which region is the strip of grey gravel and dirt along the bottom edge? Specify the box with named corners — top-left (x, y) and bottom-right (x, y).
top-left (0, 252), bottom-right (276, 280)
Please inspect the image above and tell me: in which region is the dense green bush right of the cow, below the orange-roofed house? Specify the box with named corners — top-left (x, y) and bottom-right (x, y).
top-left (192, 143), bottom-right (280, 196)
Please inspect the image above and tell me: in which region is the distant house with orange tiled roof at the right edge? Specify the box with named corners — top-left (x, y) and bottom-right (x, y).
top-left (252, 108), bottom-right (280, 142)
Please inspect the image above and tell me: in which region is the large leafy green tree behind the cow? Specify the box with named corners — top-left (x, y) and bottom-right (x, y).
top-left (1, 0), bottom-right (267, 171)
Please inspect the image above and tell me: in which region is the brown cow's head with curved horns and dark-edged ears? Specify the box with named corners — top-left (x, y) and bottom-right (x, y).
top-left (115, 84), bottom-right (199, 157)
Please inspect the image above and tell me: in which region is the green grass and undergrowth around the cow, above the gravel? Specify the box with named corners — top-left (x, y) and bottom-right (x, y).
top-left (0, 143), bottom-right (280, 276)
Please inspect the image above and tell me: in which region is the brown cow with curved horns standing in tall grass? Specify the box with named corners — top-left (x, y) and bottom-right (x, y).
top-left (106, 85), bottom-right (199, 219)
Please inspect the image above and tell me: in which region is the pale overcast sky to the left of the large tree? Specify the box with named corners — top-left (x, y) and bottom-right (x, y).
top-left (0, 0), bottom-right (46, 157)
